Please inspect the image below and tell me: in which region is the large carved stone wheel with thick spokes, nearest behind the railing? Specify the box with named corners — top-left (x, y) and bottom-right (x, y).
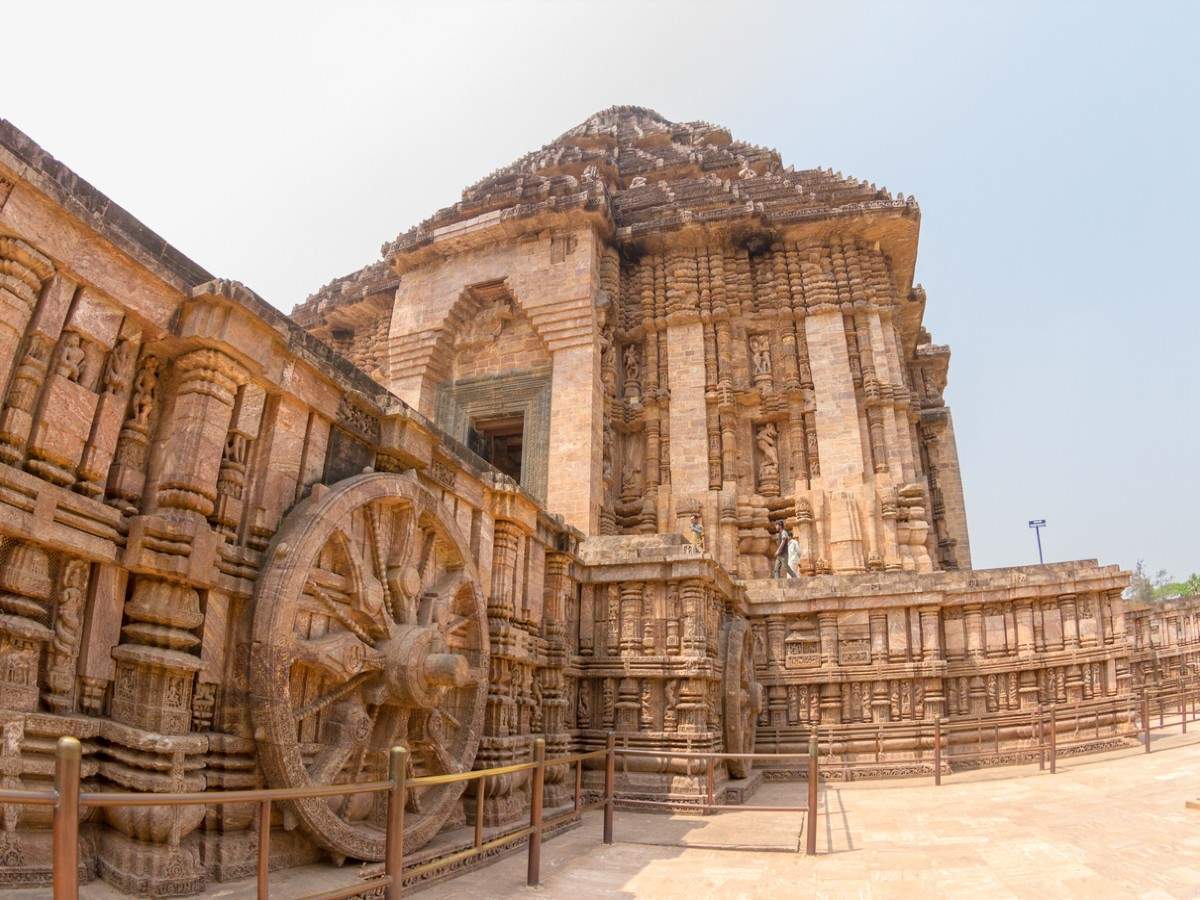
top-left (251, 473), bottom-right (488, 862)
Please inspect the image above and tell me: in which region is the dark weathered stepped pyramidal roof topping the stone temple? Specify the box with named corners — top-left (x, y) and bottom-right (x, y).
top-left (293, 106), bottom-right (919, 322)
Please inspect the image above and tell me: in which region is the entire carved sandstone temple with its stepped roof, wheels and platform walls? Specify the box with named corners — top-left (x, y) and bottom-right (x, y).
top-left (0, 107), bottom-right (1200, 895)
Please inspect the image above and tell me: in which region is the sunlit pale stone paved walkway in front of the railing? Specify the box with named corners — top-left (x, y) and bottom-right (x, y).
top-left (419, 734), bottom-right (1200, 900)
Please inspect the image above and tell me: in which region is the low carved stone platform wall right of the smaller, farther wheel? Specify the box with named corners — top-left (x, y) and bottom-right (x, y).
top-left (745, 560), bottom-right (1134, 774)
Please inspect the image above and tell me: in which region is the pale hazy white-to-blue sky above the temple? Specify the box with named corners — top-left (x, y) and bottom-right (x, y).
top-left (0, 1), bottom-right (1200, 576)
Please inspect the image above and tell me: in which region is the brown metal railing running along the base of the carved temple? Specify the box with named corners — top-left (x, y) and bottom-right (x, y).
top-left (0, 679), bottom-right (1200, 900)
